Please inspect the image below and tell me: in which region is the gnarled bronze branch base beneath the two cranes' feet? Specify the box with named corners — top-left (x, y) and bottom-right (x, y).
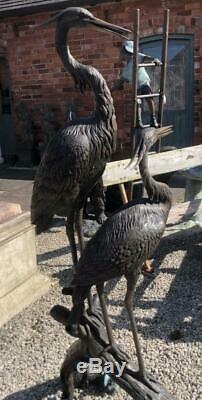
top-left (51, 297), bottom-right (174, 400)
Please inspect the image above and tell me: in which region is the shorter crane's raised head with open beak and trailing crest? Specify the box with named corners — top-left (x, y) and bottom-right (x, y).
top-left (129, 125), bottom-right (173, 167)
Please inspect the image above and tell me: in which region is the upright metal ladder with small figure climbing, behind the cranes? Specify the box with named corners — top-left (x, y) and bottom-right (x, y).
top-left (119, 9), bottom-right (170, 203)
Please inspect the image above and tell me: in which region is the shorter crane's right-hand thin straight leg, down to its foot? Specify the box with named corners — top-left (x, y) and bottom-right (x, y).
top-left (125, 270), bottom-right (159, 391)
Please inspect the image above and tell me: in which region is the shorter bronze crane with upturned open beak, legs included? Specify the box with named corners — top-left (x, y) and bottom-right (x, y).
top-left (63, 126), bottom-right (172, 387)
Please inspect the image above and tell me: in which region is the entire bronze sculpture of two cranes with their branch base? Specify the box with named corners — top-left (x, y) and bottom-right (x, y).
top-left (28, 8), bottom-right (175, 400)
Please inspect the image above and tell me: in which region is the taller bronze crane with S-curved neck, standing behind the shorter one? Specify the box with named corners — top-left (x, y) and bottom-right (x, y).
top-left (31, 7), bottom-right (130, 265)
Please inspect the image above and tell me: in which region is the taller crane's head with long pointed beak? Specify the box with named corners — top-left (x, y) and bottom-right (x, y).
top-left (58, 7), bottom-right (131, 39)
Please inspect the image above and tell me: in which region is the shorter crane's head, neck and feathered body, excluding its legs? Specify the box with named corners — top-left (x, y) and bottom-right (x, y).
top-left (72, 126), bottom-right (172, 288)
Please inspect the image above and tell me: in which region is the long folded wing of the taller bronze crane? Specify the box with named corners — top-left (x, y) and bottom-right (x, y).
top-left (31, 125), bottom-right (89, 233)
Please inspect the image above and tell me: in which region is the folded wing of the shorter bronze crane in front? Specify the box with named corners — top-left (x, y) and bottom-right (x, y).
top-left (72, 203), bottom-right (166, 286)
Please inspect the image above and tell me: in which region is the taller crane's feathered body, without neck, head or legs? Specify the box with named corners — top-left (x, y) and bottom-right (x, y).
top-left (32, 109), bottom-right (115, 231)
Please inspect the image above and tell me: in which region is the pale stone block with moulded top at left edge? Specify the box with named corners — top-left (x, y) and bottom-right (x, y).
top-left (0, 208), bottom-right (49, 326)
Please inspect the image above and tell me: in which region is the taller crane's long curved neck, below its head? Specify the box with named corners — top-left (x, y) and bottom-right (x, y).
top-left (56, 23), bottom-right (116, 130)
